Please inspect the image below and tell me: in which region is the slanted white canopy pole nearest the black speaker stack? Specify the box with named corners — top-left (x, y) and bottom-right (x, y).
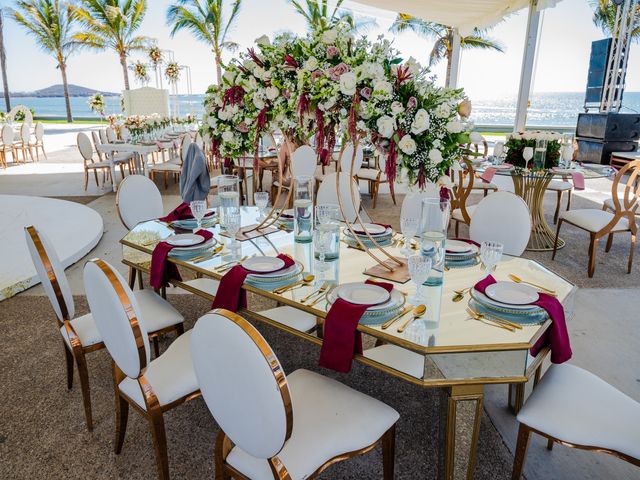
top-left (513, 0), bottom-right (540, 132)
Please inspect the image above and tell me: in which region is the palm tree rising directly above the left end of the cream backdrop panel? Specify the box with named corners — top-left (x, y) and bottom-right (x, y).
top-left (73, 0), bottom-right (152, 90)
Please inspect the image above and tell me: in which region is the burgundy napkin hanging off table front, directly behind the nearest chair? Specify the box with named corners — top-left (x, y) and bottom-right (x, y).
top-left (319, 280), bottom-right (393, 373)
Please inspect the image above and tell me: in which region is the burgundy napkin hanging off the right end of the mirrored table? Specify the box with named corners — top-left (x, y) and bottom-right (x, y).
top-left (475, 275), bottom-right (572, 363)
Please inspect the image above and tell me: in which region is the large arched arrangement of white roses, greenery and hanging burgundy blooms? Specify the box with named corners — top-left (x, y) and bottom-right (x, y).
top-left (204, 21), bottom-right (471, 187)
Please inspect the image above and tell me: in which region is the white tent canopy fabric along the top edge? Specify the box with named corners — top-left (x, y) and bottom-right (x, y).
top-left (355, 0), bottom-right (560, 36)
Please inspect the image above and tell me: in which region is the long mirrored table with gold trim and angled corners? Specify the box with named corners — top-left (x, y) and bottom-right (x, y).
top-left (121, 207), bottom-right (576, 479)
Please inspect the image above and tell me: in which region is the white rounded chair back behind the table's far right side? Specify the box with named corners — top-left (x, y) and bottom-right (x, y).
top-left (469, 192), bottom-right (531, 257)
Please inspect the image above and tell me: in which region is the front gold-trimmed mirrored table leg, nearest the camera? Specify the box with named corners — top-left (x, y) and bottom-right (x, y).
top-left (438, 385), bottom-right (484, 480)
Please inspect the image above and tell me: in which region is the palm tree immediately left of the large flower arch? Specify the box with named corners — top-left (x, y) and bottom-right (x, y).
top-left (167, 0), bottom-right (241, 84)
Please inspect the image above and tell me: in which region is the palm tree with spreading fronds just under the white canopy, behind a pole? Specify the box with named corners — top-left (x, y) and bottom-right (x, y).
top-left (389, 13), bottom-right (504, 86)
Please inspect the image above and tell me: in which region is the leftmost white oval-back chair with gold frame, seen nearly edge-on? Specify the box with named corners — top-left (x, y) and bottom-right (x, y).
top-left (25, 225), bottom-right (184, 430)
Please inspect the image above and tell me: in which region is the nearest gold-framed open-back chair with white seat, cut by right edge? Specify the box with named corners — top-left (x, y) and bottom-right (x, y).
top-left (551, 160), bottom-right (640, 278)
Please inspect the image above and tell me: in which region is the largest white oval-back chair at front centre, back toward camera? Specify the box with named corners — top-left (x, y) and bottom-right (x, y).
top-left (191, 310), bottom-right (399, 480)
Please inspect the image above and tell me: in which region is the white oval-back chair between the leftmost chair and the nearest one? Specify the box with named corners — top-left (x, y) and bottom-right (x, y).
top-left (84, 259), bottom-right (200, 480)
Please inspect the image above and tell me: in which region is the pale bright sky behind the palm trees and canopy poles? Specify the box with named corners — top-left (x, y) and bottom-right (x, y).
top-left (0, 0), bottom-right (640, 100)
